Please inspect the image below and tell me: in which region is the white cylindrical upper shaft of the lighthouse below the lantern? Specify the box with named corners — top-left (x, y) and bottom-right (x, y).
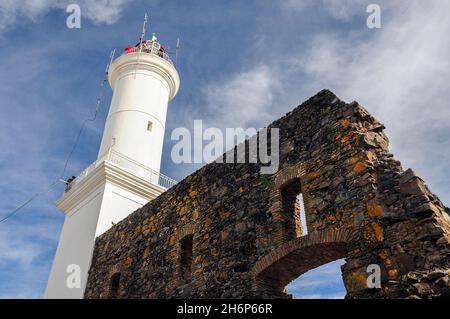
top-left (98, 53), bottom-right (179, 172)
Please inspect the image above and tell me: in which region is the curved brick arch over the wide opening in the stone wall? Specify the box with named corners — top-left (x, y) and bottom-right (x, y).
top-left (251, 229), bottom-right (357, 297)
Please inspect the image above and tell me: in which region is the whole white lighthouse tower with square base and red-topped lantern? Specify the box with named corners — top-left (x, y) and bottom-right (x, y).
top-left (45, 23), bottom-right (180, 298)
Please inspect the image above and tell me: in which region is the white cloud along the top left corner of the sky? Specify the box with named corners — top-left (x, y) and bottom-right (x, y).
top-left (0, 0), bottom-right (130, 32)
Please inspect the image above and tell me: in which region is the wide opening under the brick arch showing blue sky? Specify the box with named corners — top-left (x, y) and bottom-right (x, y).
top-left (286, 259), bottom-right (346, 299)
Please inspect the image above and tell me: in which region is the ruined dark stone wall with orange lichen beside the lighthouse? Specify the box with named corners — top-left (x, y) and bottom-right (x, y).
top-left (85, 90), bottom-right (450, 298)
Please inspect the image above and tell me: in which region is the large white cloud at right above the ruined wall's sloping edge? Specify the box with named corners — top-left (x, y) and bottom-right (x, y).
top-left (297, 1), bottom-right (450, 201)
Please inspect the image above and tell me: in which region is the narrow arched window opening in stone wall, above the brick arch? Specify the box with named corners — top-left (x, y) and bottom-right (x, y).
top-left (281, 178), bottom-right (307, 240)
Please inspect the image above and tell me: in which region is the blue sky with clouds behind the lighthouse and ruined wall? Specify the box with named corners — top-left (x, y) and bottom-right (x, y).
top-left (0, 0), bottom-right (450, 298)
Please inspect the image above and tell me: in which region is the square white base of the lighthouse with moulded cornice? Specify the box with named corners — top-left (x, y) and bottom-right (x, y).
top-left (45, 160), bottom-right (166, 299)
